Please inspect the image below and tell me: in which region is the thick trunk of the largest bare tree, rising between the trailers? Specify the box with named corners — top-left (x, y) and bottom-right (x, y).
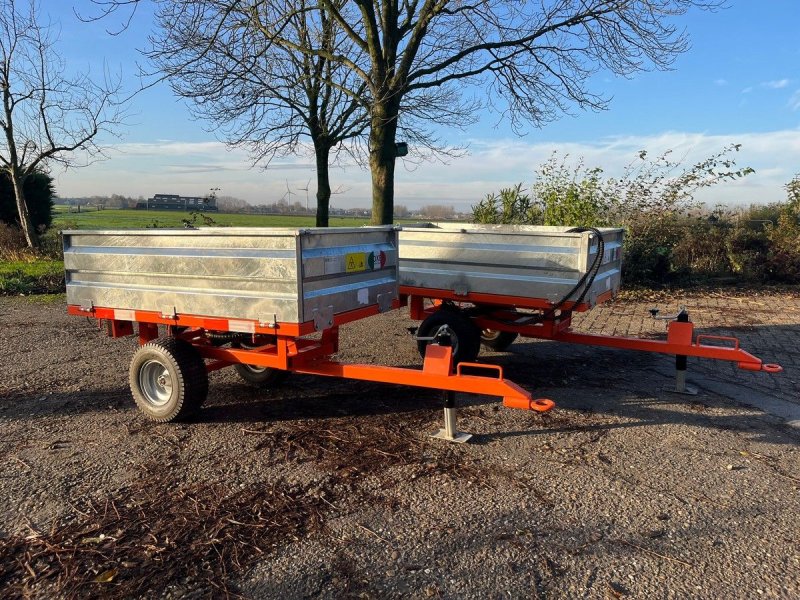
top-left (369, 103), bottom-right (399, 225)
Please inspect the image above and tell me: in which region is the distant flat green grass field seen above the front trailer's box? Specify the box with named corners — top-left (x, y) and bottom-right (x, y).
top-left (53, 206), bottom-right (368, 229)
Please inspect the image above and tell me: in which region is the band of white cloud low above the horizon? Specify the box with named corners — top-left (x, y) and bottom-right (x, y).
top-left (57, 129), bottom-right (800, 210)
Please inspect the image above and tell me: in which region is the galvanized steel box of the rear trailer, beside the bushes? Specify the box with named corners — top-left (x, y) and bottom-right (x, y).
top-left (400, 223), bottom-right (623, 305)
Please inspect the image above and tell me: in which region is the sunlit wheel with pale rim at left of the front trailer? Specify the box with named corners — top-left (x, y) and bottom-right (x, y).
top-left (129, 336), bottom-right (208, 423)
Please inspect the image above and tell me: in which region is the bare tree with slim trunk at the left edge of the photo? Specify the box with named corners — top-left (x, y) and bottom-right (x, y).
top-left (0, 0), bottom-right (121, 247)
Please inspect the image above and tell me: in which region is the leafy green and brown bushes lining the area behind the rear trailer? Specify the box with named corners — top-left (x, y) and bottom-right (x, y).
top-left (473, 154), bottom-right (800, 285)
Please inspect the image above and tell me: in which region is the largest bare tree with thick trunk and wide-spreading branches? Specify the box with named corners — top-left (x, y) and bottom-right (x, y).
top-left (252, 0), bottom-right (719, 223)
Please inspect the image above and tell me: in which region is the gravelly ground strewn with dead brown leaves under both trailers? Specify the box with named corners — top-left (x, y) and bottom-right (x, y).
top-left (0, 292), bottom-right (800, 599)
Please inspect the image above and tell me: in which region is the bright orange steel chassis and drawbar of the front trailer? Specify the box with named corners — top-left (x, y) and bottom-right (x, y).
top-left (67, 305), bottom-right (554, 412)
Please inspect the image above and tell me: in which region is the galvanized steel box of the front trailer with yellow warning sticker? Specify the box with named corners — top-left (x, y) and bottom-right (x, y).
top-left (64, 228), bottom-right (397, 323)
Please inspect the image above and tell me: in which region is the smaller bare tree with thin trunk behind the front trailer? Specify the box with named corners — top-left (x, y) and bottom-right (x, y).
top-left (140, 0), bottom-right (369, 227)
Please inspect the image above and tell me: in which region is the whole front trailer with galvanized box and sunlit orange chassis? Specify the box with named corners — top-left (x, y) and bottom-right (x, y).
top-left (63, 227), bottom-right (553, 441)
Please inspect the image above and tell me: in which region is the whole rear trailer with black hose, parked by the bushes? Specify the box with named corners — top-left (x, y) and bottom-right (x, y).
top-left (400, 223), bottom-right (782, 393)
